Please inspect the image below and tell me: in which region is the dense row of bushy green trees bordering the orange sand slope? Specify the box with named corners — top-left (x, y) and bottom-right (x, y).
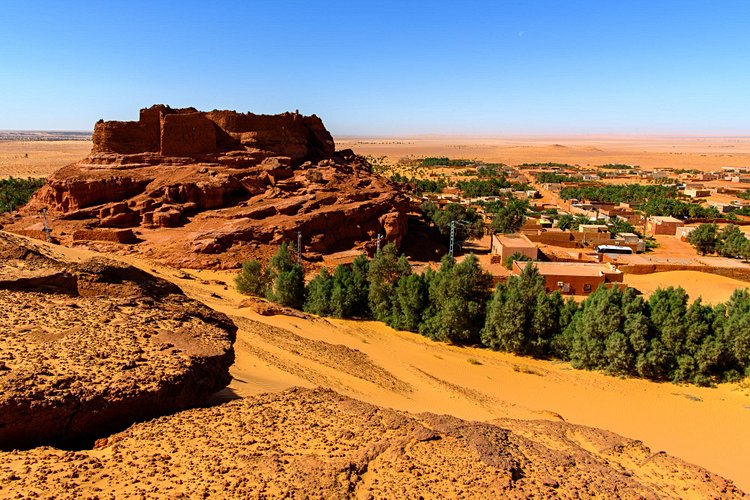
top-left (237, 244), bottom-right (750, 385)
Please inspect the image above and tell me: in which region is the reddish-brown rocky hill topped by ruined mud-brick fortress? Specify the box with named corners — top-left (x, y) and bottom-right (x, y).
top-left (2, 105), bottom-right (409, 267)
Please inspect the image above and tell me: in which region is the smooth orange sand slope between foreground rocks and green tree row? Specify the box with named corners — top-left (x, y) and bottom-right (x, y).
top-left (169, 271), bottom-right (750, 490)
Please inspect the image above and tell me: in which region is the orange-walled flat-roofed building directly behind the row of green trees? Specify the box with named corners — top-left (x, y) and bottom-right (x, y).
top-left (512, 261), bottom-right (623, 295)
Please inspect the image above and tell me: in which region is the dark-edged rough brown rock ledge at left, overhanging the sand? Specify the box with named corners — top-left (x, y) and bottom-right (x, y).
top-left (0, 233), bottom-right (236, 449)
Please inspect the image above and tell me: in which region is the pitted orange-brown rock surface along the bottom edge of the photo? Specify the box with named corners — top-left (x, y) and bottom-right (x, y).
top-left (0, 389), bottom-right (742, 498)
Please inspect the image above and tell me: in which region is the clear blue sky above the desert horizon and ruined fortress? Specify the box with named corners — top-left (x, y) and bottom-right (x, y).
top-left (0, 0), bottom-right (750, 135)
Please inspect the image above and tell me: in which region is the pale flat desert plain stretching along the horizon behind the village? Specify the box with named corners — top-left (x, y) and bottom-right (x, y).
top-left (0, 136), bottom-right (750, 182)
